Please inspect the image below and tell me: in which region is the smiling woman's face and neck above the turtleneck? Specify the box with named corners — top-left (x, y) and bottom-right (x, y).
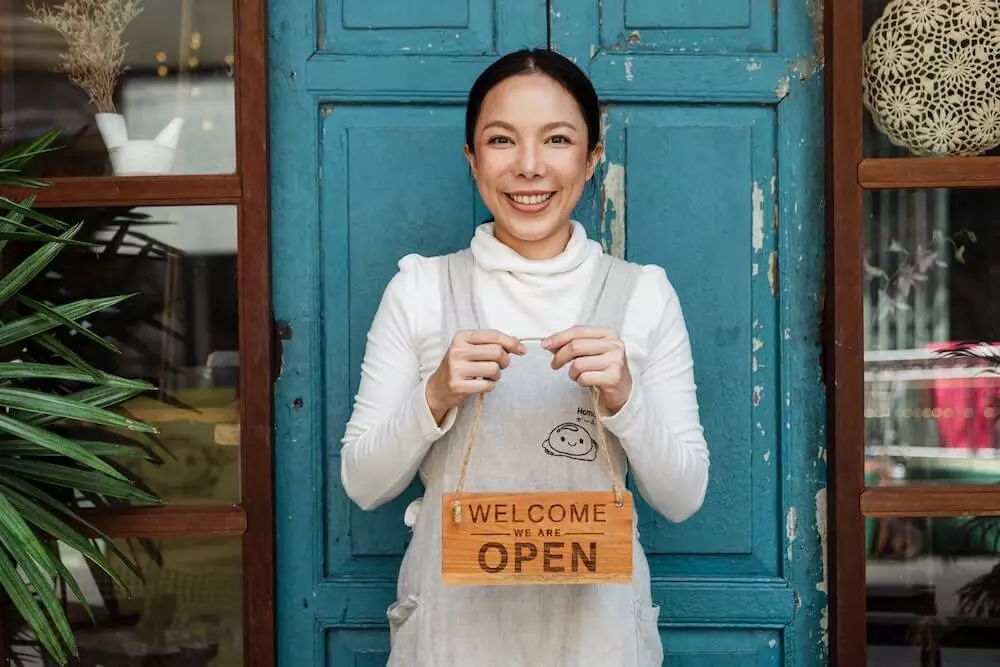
top-left (465, 73), bottom-right (601, 259)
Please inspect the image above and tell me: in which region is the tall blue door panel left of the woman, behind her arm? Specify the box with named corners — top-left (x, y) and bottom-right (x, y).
top-left (319, 103), bottom-right (485, 581)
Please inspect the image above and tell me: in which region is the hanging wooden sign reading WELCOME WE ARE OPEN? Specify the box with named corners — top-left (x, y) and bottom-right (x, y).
top-left (441, 491), bottom-right (633, 586)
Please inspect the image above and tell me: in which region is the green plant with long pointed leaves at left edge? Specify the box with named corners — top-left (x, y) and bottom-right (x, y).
top-left (0, 131), bottom-right (159, 664)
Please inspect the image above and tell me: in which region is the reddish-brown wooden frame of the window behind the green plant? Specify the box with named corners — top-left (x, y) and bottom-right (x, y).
top-left (0, 0), bottom-right (276, 667)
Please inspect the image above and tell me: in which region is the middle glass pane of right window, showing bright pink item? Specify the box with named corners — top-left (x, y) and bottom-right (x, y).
top-left (864, 190), bottom-right (1000, 485)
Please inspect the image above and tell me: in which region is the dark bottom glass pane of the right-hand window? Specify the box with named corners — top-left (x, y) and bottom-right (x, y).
top-left (866, 517), bottom-right (1000, 667)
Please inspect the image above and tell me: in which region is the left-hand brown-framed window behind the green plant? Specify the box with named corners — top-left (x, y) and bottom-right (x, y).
top-left (0, 0), bottom-right (275, 667)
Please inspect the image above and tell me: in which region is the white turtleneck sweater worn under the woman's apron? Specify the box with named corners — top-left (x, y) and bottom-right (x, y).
top-left (341, 222), bottom-right (709, 523)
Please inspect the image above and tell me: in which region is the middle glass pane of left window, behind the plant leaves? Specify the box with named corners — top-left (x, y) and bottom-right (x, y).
top-left (19, 206), bottom-right (240, 504)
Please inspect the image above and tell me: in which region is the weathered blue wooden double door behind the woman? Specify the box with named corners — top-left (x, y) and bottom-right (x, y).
top-left (269, 0), bottom-right (826, 667)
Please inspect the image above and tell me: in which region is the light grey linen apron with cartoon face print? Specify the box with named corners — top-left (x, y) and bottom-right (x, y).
top-left (388, 250), bottom-right (663, 667)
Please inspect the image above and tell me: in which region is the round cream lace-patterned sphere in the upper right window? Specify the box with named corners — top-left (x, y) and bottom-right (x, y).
top-left (864, 0), bottom-right (1000, 156)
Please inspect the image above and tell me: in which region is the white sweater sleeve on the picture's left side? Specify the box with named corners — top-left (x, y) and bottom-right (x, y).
top-left (340, 257), bottom-right (456, 510)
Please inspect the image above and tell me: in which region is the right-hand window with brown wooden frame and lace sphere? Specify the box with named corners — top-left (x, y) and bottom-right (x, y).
top-left (825, 0), bottom-right (1000, 667)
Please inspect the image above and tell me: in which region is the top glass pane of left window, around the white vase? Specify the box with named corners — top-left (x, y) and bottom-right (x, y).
top-left (0, 0), bottom-right (236, 177)
